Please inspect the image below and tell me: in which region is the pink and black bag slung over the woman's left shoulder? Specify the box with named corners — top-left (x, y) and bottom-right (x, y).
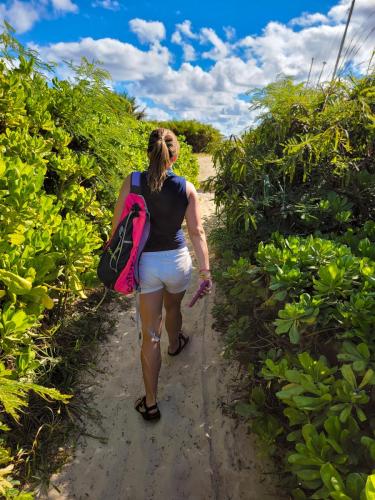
top-left (97, 172), bottom-right (150, 295)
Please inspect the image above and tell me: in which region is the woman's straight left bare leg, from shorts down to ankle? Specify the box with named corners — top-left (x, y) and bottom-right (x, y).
top-left (139, 290), bottom-right (163, 406)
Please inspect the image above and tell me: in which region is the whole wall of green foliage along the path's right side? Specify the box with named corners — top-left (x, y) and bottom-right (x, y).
top-left (212, 75), bottom-right (375, 500)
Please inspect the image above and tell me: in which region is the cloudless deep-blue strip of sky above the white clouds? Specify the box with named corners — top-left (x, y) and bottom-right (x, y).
top-left (18, 0), bottom-right (336, 48)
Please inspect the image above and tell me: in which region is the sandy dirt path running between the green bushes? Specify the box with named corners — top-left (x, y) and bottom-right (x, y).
top-left (44, 155), bottom-right (280, 500)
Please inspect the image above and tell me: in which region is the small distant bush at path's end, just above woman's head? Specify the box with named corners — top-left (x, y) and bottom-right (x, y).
top-left (158, 120), bottom-right (222, 153)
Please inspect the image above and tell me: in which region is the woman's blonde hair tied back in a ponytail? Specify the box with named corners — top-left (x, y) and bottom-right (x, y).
top-left (147, 128), bottom-right (180, 192)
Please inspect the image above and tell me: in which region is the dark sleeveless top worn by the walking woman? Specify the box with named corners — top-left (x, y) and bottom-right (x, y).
top-left (141, 169), bottom-right (188, 252)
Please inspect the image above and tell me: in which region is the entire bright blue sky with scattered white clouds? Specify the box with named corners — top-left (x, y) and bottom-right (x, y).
top-left (0, 0), bottom-right (375, 133)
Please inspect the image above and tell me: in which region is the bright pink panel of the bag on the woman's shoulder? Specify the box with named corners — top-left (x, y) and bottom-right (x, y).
top-left (114, 193), bottom-right (146, 295)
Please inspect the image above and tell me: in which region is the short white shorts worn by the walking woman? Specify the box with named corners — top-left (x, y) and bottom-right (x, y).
top-left (139, 247), bottom-right (192, 293)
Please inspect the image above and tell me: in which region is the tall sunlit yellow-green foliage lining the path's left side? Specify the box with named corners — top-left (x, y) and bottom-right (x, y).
top-left (0, 27), bottom-right (198, 498)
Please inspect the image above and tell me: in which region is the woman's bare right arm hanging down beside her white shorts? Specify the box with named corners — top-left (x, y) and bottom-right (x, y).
top-left (185, 182), bottom-right (210, 278)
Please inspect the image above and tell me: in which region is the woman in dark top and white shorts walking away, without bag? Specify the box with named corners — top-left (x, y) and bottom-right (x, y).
top-left (112, 128), bottom-right (212, 420)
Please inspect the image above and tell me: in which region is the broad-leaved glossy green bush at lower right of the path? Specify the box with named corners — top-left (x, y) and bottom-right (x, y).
top-left (218, 234), bottom-right (375, 499)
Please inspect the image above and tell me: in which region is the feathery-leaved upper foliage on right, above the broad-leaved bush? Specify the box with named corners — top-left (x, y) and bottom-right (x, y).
top-left (208, 75), bottom-right (375, 251)
